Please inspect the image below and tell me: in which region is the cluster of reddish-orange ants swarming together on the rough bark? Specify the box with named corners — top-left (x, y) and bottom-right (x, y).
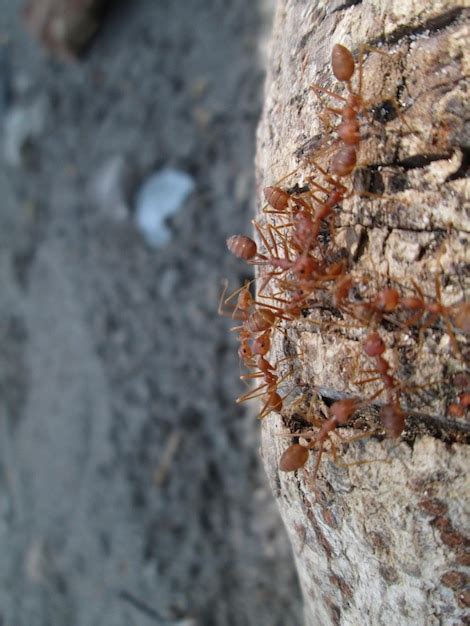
top-left (219, 44), bottom-right (470, 479)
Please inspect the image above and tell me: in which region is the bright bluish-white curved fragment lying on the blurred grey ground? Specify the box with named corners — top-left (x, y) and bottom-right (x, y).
top-left (135, 168), bottom-right (195, 248)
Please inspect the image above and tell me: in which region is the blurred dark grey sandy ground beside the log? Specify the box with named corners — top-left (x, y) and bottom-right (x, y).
top-left (0, 0), bottom-right (301, 626)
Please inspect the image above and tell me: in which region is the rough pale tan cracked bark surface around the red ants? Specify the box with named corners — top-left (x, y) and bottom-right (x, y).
top-left (257, 0), bottom-right (470, 626)
